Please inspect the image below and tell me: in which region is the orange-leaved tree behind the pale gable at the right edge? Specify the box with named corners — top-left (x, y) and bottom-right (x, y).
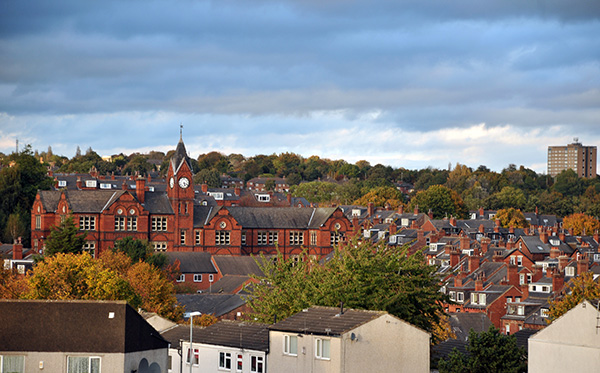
top-left (548, 272), bottom-right (600, 322)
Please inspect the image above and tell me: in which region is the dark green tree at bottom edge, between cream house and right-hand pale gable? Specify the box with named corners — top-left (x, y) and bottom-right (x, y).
top-left (438, 326), bottom-right (527, 373)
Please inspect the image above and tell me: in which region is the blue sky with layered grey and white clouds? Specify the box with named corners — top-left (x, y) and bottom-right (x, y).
top-left (0, 0), bottom-right (600, 173)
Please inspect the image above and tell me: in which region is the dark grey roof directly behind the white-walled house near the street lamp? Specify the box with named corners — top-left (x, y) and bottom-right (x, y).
top-left (176, 294), bottom-right (246, 317)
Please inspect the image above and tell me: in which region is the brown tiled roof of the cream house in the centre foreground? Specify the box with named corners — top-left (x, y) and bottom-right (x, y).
top-left (270, 306), bottom-right (386, 336)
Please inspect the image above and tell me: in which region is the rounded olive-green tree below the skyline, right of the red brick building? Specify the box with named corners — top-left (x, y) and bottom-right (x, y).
top-left (410, 185), bottom-right (467, 219)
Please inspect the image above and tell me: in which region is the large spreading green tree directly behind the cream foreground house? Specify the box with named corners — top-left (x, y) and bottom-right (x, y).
top-left (249, 238), bottom-right (445, 338)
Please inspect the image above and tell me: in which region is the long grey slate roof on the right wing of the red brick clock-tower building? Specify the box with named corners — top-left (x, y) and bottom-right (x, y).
top-left (227, 207), bottom-right (336, 229)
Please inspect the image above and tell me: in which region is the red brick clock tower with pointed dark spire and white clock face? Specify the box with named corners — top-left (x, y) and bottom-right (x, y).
top-left (167, 134), bottom-right (194, 251)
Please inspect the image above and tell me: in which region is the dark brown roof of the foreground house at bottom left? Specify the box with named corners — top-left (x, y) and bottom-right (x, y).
top-left (0, 299), bottom-right (168, 353)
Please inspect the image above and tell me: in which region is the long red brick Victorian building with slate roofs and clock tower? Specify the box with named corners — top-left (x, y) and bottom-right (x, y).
top-left (31, 139), bottom-right (352, 257)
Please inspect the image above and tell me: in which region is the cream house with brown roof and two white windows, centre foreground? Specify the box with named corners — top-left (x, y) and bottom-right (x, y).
top-left (268, 307), bottom-right (430, 373)
